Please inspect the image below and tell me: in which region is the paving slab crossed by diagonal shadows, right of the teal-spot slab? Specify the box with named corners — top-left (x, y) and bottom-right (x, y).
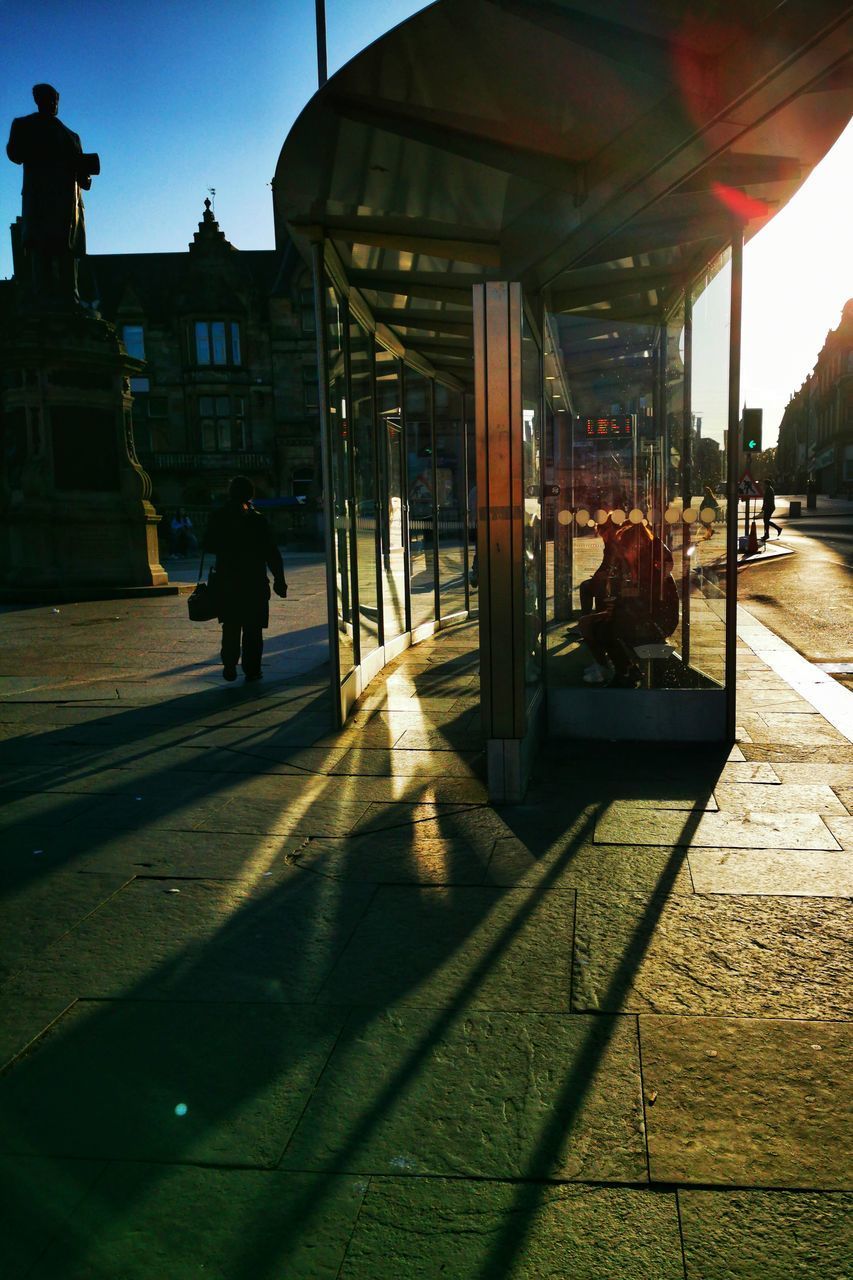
top-left (282, 1009), bottom-right (647, 1183)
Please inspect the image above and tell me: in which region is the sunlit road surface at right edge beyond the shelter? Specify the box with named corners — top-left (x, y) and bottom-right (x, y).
top-left (738, 503), bottom-right (853, 689)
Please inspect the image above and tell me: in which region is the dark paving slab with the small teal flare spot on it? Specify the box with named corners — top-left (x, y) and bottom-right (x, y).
top-left (0, 1000), bottom-right (343, 1167)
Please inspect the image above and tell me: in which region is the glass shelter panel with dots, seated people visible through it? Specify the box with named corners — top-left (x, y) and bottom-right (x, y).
top-left (540, 270), bottom-right (729, 689)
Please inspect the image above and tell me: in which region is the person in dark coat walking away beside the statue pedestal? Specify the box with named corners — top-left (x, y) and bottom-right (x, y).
top-left (205, 476), bottom-right (287, 680)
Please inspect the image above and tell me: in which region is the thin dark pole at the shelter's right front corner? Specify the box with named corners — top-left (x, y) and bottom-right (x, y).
top-left (726, 223), bottom-right (743, 742)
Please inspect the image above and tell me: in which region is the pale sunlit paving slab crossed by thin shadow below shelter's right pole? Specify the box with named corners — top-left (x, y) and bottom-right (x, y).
top-left (596, 788), bottom-right (839, 849)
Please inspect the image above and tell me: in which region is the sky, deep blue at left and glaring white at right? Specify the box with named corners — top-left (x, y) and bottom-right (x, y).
top-left (0, 0), bottom-right (853, 443)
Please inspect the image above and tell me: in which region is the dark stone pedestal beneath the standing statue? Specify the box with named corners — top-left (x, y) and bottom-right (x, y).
top-left (0, 311), bottom-right (175, 599)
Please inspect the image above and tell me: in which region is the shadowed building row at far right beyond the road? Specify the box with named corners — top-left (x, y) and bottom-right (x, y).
top-left (776, 298), bottom-right (853, 494)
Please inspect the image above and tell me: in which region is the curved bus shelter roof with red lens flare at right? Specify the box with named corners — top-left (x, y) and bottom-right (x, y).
top-left (273, 0), bottom-right (853, 381)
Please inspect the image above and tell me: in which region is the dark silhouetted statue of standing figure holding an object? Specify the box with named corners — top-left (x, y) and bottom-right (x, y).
top-left (6, 84), bottom-right (101, 307)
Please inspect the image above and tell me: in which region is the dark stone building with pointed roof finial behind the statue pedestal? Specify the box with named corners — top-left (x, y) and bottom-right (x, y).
top-left (81, 200), bottom-right (320, 536)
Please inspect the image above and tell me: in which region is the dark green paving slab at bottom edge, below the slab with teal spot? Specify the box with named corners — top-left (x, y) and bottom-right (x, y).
top-left (29, 1164), bottom-right (366, 1280)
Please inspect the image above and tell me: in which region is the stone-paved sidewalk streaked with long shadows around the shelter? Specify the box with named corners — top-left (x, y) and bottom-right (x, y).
top-left (0, 586), bottom-right (853, 1280)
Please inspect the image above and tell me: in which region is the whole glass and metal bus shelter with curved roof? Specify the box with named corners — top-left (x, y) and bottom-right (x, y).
top-left (273, 0), bottom-right (853, 800)
